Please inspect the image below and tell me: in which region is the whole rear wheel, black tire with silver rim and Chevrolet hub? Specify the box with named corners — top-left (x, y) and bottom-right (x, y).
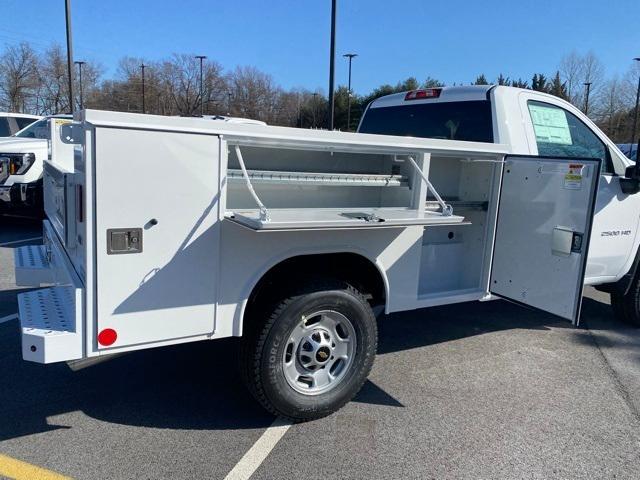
top-left (242, 280), bottom-right (377, 421)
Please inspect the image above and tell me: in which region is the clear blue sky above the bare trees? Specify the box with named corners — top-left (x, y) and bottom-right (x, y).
top-left (5, 0), bottom-right (640, 93)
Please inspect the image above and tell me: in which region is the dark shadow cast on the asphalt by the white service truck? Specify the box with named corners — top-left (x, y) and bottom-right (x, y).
top-left (0, 302), bottom-right (570, 440)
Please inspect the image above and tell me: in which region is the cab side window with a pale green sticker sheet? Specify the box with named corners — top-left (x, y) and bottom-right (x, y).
top-left (527, 100), bottom-right (613, 173)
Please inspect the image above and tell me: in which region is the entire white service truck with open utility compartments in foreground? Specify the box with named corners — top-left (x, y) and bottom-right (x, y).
top-left (10, 87), bottom-right (640, 420)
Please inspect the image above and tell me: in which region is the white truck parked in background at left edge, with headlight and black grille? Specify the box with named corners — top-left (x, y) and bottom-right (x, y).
top-left (0, 115), bottom-right (72, 215)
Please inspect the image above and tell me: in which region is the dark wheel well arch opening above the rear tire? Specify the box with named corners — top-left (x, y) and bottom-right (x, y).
top-left (245, 253), bottom-right (386, 318)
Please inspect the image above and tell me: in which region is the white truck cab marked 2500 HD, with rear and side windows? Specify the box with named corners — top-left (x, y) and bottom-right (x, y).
top-left (358, 85), bottom-right (640, 300)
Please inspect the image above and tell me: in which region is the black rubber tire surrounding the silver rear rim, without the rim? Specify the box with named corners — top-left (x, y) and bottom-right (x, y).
top-left (240, 280), bottom-right (378, 421)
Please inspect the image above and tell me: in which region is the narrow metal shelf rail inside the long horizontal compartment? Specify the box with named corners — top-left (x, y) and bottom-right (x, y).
top-left (227, 169), bottom-right (409, 187)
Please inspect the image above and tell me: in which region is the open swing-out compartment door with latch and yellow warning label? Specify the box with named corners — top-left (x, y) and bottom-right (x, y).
top-left (490, 156), bottom-right (600, 325)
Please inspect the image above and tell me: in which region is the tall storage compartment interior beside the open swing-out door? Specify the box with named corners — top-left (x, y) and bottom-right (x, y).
top-left (418, 157), bottom-right (497, 297)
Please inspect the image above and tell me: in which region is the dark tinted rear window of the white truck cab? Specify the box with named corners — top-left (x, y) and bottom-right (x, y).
top-left (358, 100), bottom-right (493, 143)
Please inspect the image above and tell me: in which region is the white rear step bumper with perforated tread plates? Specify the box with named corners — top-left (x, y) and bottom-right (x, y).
top-left (14, 221), bottom-right (84, 363)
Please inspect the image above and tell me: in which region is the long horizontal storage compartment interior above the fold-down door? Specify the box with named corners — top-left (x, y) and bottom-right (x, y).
top-left (226, 146), bottom-right (415, 210)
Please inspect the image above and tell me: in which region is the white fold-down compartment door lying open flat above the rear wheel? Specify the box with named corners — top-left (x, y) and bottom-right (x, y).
top-left (225, 208), bottom-right (464, 231)
